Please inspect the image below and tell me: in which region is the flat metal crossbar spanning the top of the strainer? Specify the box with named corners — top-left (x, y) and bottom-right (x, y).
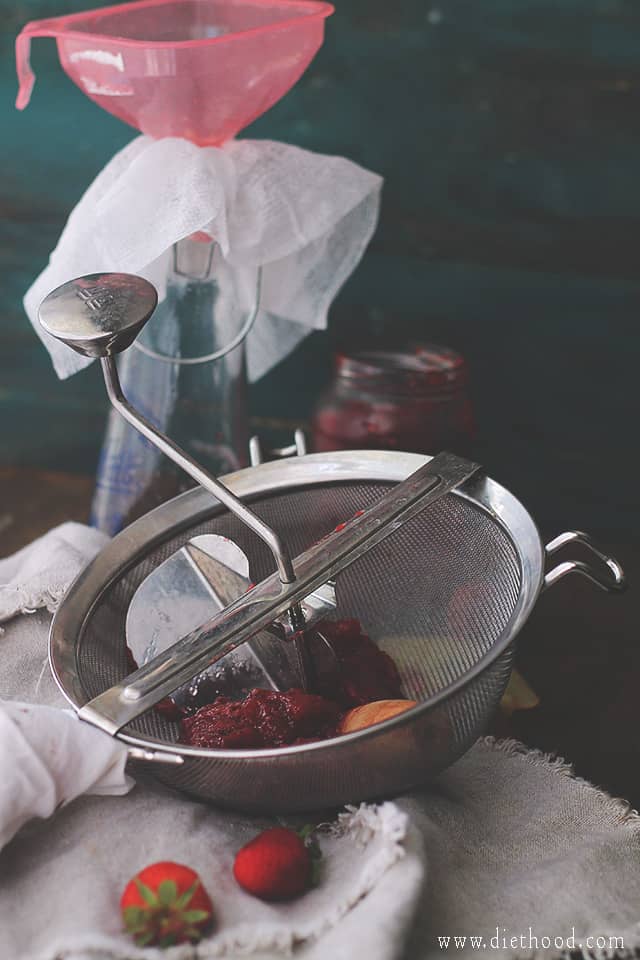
top-left (79, 453), bottom-right (481, 735)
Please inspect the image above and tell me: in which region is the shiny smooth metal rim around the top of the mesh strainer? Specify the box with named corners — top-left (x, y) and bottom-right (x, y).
top-left (49, 450), bottom-right (545, 760)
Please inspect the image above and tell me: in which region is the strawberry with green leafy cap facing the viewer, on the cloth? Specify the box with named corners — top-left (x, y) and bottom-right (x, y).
top-left (120, 861), bottom-right (213, 947)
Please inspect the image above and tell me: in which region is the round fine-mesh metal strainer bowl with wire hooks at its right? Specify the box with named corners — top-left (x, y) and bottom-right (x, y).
top-left (50, 451), bottom-right (623, 813)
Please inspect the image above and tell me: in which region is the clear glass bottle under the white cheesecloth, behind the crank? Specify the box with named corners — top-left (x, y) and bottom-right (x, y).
top-left (91, 234), bottom-right (260, 534)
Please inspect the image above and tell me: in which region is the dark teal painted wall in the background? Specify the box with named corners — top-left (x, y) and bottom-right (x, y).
top-left (0, 0), bottom-right (640, 536)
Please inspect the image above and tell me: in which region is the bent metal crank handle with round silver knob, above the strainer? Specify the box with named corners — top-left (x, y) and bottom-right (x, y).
top-left (38, 273), bottom-right (335, 690)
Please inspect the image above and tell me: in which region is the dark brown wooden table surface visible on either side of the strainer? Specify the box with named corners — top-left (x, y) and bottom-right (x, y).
top-left (0, 468), bottom-right (640, 806)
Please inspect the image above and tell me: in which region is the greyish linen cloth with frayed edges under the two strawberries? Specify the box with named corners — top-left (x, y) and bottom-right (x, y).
top-left (0, 531), bottom-right (640, 960)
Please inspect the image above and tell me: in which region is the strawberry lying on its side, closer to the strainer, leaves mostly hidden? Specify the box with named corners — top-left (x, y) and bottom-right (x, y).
top-left (233, 827), bottom-right (319, 900)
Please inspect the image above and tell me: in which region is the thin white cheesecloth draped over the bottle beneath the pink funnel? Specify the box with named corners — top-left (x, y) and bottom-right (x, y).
top-left (24, 136), bottom-right (382, 381)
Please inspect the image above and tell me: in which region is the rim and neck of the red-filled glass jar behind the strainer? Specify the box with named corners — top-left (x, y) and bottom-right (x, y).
top-left (336, 343), bottom-right (467, 394)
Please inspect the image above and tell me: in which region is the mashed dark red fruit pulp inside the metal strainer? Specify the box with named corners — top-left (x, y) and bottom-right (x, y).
top-left (180, 620), bottom-right (402, 749)
